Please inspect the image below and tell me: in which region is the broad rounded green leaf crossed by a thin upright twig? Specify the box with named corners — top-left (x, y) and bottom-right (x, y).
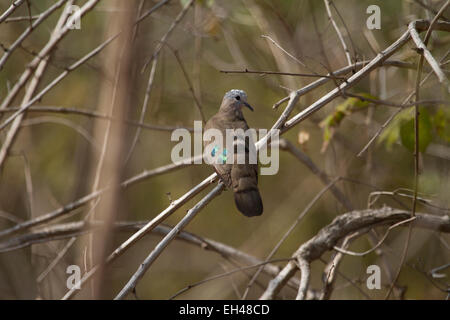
top-left (400, 108), bottom-right (433, 152)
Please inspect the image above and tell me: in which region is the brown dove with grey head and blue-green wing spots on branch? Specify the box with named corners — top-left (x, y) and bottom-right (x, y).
top-left (204, 89), bottom-right (263, 217)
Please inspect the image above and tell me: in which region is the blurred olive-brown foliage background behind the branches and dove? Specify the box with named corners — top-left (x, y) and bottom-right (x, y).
top-left (0, 0), bottom-right (450, 299)
